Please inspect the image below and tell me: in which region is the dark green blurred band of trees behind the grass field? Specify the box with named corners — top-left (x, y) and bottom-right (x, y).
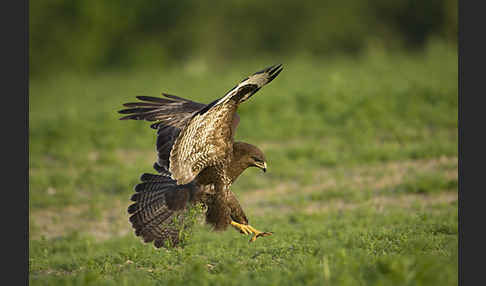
top-left (29, 0), bottom-right (457, 76)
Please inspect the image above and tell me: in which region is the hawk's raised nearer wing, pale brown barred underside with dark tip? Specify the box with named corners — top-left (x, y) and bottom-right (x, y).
top-left (169, 65), bottom-right (282, 184)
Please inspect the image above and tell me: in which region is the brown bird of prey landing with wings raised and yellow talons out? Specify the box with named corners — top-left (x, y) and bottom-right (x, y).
top-left (119, 64), bottom-right (282, 248)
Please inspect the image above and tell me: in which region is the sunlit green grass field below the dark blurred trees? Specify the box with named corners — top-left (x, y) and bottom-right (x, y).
top-left (29, 44), bottom-right (458, 286)
